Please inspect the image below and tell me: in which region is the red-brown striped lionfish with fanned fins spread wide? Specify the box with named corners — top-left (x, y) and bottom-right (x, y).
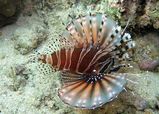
top-left (34, 13), bottom-right (135, 109)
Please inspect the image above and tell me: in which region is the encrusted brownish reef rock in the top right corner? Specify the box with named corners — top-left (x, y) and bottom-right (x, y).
top-left (120, 0), bottom-right (159, 29)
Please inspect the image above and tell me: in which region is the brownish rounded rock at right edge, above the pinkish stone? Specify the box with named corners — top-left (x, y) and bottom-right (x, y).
top-left (134, 32), bottom-right (159, 64)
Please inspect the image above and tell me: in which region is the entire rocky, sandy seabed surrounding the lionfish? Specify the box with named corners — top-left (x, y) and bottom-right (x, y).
top-left (0, 0), bottom-right (159, 114)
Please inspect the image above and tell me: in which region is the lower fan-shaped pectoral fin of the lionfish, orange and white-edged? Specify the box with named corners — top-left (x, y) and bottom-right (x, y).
top-left (59, 74), bottom-right (126, 109)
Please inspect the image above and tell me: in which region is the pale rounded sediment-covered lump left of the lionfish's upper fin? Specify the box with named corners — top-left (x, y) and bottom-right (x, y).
top-left (12, 16), bottom-right (47, 54)
